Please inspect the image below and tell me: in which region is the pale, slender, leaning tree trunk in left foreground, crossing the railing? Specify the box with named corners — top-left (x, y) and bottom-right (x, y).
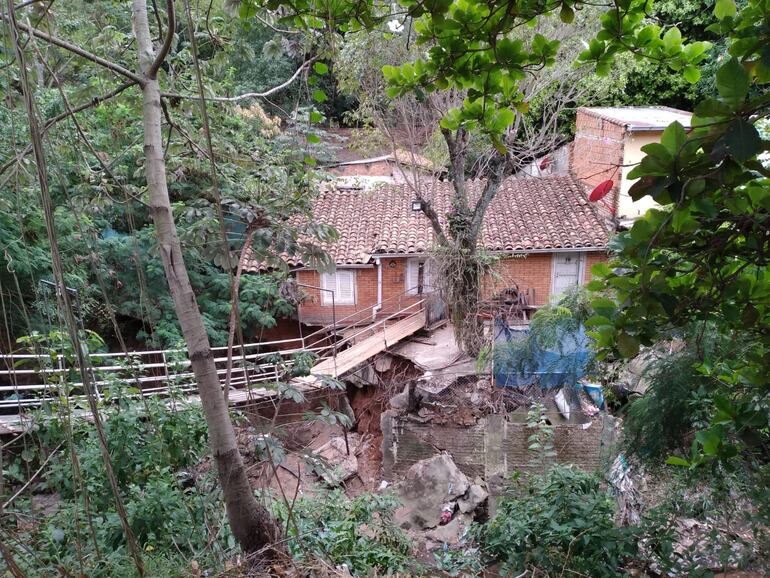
top-left (133, 0), bottom-right (282, 555)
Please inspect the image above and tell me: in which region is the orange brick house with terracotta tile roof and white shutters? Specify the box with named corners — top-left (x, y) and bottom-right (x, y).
top-left (244, 176), bottom-right (609, 326)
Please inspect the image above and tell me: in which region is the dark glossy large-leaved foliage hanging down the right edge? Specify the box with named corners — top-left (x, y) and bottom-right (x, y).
top-left (590, 0), bottom-right (770, 464)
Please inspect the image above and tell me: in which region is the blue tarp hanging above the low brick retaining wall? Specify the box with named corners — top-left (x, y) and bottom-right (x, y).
top-left (493, 320), bottom-right (592, 388)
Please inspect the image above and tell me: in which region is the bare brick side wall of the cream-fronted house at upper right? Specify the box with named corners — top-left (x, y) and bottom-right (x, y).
top-left (572, 109), bottom-right (626, 213)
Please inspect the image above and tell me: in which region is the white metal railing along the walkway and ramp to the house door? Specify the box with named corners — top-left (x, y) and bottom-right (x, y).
top-left (0, 282), bottom-right (440, 414)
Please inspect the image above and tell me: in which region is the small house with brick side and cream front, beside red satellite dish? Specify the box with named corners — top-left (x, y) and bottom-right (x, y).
top-left (571, 106), bottom-right (692, 221)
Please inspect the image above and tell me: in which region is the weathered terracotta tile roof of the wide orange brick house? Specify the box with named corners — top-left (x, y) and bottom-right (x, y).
top-left (246, 176), bottom-right (609, 270)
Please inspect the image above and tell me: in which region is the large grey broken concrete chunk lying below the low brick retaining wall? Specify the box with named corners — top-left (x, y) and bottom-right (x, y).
top-left (396, 454), bottom-right (471, 529)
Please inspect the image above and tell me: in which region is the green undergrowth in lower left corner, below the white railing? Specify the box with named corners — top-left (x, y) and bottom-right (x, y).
top-left (0, 398), bottom-right (228, 578)
